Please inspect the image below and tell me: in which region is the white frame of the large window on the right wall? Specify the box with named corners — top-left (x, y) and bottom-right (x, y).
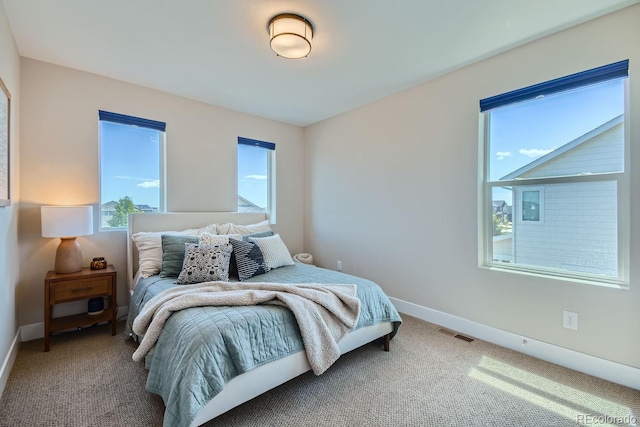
top-left (478, 60), bottom-right (631, 289)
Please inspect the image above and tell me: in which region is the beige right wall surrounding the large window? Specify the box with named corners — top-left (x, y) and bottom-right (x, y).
top-left (305, 5), bottom-right (640, 368)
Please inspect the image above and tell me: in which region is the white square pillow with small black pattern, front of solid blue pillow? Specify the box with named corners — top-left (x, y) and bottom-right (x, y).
top-left (176, 243), bottom-right (233, 285)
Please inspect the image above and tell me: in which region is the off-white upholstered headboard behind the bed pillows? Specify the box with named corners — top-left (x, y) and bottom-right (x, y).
top-left (127, 212), bottom-right (268, 289)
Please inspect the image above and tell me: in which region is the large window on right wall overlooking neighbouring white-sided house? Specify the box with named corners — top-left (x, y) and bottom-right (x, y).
top-left (479, 60), bottom-right (630, 287)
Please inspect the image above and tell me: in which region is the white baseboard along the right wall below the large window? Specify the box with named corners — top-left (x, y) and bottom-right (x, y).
top-left (390, 298), bottom-right (640, 390)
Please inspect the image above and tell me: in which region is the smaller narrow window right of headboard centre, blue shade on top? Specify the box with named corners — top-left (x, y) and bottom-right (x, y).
top-left (238, 137), bottom-right (276, 223)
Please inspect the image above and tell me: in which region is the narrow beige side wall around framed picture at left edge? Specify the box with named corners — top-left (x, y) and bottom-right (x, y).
top-left (0, 3), bottom-right (20, 394)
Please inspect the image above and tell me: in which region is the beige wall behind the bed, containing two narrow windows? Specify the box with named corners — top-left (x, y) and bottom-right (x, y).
top-left (18, 58), bottom-right (304, 325)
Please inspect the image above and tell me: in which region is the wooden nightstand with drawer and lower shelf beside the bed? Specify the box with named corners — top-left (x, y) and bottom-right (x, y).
top-left (44, 265), bottom-right (118, 351)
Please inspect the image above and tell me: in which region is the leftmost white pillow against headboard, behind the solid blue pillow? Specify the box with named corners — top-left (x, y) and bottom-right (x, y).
top-left (131, 224), bottom-right (217, 279)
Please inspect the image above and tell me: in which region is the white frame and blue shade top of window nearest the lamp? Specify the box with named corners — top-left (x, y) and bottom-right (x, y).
top-left (98, 110), bottom-right (167, 232)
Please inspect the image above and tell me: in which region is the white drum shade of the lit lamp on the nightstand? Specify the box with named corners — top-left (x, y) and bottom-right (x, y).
top-left (40, 206), bottom-right (93, 237)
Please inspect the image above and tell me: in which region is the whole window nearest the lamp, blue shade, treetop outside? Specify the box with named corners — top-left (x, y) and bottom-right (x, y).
top-left (98, 111), bottom-right (166, 230)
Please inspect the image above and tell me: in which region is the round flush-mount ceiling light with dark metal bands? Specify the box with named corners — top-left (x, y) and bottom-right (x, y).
top-left (269, 13), bottom-right (313, 59)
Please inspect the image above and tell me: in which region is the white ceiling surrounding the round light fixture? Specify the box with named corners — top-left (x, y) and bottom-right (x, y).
top-left (2, 0), bottom-right (640, 126)
